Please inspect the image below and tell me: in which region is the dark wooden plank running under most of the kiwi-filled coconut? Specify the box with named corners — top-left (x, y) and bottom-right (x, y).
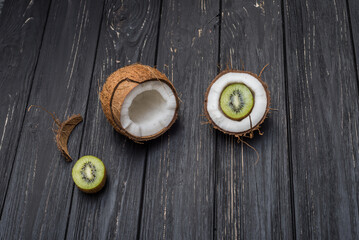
top-left (216, 0), bottom-right (293, 239)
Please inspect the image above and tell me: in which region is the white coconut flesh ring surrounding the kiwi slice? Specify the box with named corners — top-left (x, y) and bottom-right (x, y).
top-left (207, 72), bottom-right (268, 133)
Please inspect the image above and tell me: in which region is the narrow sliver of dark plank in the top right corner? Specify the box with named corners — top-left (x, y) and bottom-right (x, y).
top-left (347, 0), bottom-right (359, 76)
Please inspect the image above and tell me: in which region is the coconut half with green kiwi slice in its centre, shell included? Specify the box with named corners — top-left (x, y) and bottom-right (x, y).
top-left (204, 67), bottom-right (270, 139)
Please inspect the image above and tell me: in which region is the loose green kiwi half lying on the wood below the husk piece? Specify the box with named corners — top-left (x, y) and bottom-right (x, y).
top-left (72, 155), bottom-right (106, 193)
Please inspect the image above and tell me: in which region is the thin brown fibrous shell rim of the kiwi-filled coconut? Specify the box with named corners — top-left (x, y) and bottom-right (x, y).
top-left (204, 69), bottom-right (270, 138)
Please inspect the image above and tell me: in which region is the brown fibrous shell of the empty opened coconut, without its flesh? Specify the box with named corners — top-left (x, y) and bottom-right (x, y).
top-left (100, 64), bottom-right (179, 142)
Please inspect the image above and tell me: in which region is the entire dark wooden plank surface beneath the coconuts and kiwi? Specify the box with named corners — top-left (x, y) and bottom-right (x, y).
top-left (0, 0), bottom-right (359, 239)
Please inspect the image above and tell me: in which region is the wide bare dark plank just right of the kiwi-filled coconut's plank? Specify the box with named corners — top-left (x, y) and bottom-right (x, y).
top-left (284, 0), bottom-right (359, 239)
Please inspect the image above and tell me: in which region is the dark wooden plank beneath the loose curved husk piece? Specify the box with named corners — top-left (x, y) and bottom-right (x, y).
top-left (0, 0), bottom-right (103, 239)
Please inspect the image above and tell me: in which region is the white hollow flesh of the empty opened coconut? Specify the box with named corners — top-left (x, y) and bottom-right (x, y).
top-left (120, 80), bottom-right (177, 137)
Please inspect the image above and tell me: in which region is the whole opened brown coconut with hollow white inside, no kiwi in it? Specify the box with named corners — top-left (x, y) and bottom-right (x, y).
top-left (100, 64), bottom-right (179, 142)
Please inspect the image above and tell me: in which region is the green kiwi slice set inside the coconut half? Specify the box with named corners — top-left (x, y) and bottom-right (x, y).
top-left (219, 83), bottom-right (254, 120)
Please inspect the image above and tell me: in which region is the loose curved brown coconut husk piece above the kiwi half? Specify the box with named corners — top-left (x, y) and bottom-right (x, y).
top-left (28, 105), bottom-right (83, 162)
